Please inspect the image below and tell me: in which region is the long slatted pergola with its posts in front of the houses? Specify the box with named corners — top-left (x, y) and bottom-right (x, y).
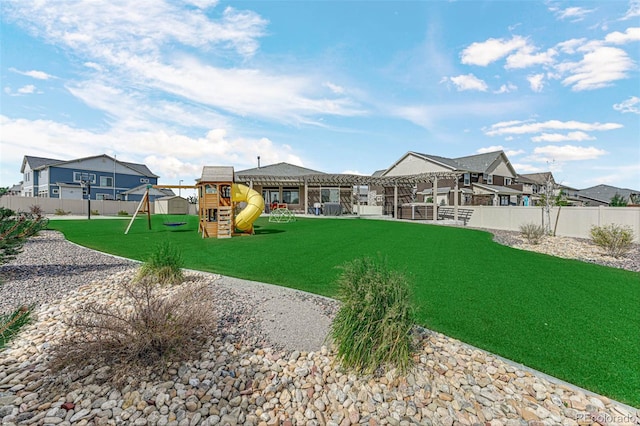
top-left (235, 171), bottom-right (464, 221)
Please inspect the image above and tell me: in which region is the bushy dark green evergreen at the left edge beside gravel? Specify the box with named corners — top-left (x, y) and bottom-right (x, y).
top-left (0, 207), bottom-right (49, 265)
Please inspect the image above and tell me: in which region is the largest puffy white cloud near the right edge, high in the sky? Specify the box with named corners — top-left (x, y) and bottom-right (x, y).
top-left (558, 46), bottom-right (635, 92)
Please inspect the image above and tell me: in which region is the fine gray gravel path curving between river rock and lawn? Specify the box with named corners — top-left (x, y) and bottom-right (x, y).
top-left (0, 231), bottom-right (338, 351)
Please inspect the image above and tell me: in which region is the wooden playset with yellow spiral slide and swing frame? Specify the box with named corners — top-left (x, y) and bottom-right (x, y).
top-left (124, 166), bottom-right (264, 238)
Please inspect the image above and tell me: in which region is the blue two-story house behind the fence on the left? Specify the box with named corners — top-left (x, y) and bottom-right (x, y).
top-left (20, 154), bottom-right (174, 201)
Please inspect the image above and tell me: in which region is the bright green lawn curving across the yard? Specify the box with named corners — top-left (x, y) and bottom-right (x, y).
top-left (49, 216), bottom-right (640, 407)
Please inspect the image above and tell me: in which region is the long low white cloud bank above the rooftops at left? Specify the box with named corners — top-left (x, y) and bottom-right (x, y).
top-left (0, 115), bottom-right (304, 181)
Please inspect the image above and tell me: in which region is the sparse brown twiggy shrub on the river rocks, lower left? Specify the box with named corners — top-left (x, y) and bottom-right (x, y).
top-left (50, 280), bottom-right (216, 384)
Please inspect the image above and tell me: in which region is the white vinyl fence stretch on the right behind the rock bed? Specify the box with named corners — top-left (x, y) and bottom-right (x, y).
top-left (460, 206), bottom-right (640, 243)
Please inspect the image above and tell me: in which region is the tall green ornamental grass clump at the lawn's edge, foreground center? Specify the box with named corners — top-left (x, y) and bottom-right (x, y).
top-left (330, 258), bottom-right (414, 374)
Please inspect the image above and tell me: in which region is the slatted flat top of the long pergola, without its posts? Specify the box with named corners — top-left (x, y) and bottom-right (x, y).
top-left (236, 171), bottom-right (464, 186)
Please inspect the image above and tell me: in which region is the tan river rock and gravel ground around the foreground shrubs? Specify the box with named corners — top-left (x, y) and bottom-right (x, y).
top-left (0, 231), bottom-right (640, 426)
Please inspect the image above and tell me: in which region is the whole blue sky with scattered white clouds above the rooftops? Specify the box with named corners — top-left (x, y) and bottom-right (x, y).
top-left (0, 0), bottom-right (640, 189)
